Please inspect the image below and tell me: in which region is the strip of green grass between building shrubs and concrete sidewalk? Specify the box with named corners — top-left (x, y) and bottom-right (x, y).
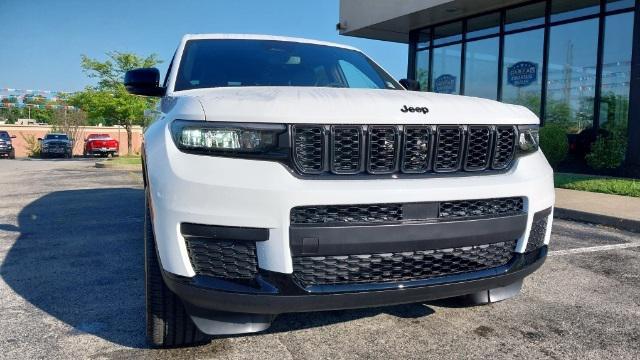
top-left (555, 173), bottom-right (640, 197)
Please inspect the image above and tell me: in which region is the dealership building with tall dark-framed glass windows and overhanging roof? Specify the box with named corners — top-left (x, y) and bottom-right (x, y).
top-left (338, 0), bottom-right (640, 168)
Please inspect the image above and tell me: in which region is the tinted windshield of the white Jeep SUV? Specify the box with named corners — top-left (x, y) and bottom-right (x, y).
top-left (175, 40), bottom-right (402, 91)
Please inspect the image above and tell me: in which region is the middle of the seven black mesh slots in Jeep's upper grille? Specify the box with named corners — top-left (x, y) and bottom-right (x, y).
top-left (402, 126), bottom-right (431, 173)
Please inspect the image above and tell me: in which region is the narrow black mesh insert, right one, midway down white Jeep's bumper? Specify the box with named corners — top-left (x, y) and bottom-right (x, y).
top-left (438, 197), bottom-right (524, 218)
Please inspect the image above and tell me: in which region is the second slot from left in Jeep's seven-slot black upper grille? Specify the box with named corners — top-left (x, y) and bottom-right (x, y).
top-left (331, 126), bottom-right (362, 174)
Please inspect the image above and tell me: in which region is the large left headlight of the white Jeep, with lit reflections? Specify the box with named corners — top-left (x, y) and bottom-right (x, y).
top-left (171, 120), bottom-right (288, 158)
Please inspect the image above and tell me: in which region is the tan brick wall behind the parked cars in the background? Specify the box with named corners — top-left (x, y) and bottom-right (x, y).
top-left (0, 125), bottom-right (142, 157)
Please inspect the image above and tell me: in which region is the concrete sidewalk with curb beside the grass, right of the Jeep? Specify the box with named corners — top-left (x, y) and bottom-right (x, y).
top-left (554, 189), bottom-right (640, 232)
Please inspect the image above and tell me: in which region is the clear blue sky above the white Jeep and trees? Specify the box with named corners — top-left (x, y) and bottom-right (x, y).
top-left (0, 0), bottom-right (407, 91)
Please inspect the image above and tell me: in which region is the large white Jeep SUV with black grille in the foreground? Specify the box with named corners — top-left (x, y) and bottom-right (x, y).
top-left (125, 35), bottom-right (554, 346)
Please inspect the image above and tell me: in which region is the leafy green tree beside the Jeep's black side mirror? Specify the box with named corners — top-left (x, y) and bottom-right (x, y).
top-left (69, 51), bottom-right (162, 154)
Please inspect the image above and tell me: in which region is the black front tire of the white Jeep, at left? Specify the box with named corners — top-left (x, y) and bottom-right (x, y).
top-left (144, 190), bottom-right (210, 348)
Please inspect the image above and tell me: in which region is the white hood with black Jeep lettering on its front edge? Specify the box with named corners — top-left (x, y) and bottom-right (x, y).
top-left (176, 87), bottom-right (539, 124)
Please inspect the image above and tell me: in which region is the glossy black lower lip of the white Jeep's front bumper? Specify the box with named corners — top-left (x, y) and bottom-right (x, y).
top-left (163, 246), bottom-right (547, 314)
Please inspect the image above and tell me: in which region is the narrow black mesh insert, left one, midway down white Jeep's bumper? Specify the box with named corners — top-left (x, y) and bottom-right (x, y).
top-left (291, 204), bottom-right (402, 224)
